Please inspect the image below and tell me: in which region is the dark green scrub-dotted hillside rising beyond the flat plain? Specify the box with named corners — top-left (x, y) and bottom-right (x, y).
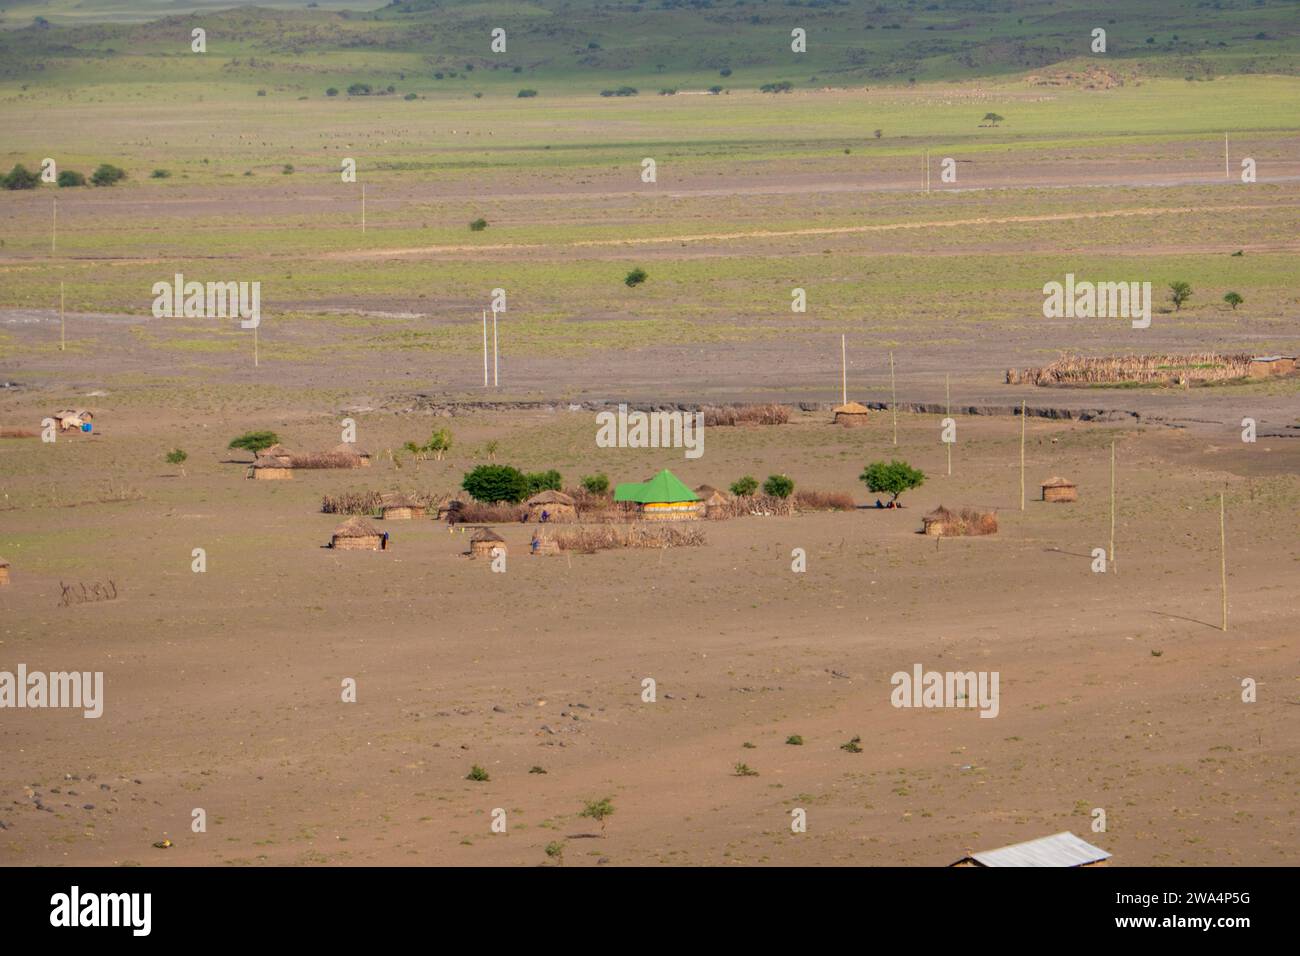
top-left (0, 0), bottom-right (1300, 92)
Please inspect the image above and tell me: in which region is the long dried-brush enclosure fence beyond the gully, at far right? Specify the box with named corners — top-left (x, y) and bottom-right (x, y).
top-left (1006, 352), bottom-right (1251, 386)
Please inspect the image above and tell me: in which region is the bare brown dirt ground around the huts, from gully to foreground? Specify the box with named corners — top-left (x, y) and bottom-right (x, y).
top-left (0, 395), bottom-right (1300, 865)
